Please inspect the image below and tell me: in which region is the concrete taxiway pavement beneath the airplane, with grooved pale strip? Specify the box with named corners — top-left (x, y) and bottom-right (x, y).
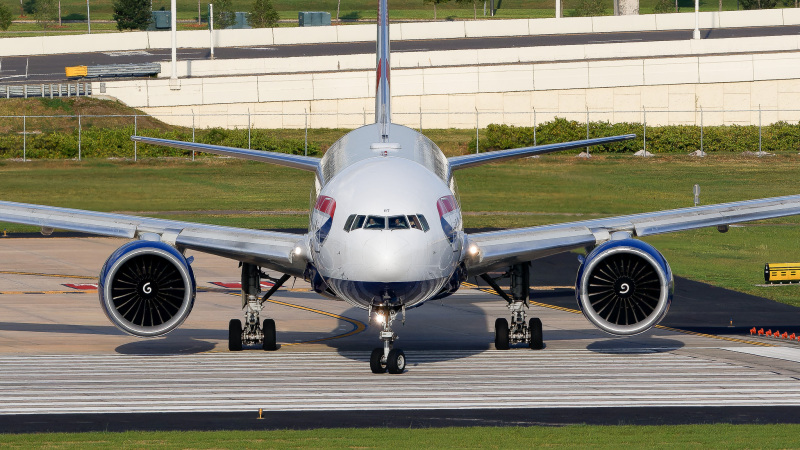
top-left (0, 238), bottom-right (800, 431)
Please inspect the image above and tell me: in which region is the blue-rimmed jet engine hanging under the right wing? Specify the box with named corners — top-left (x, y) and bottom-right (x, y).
top-left (575, 238), bottom-right (673, 335)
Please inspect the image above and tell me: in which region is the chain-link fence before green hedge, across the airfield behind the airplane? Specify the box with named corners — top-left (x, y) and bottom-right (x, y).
top-left (0, 108), bottom-right (800, 160)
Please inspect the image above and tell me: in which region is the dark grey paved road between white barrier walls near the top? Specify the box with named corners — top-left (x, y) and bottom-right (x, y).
top-left (0, 26), bottom-right (800, 84)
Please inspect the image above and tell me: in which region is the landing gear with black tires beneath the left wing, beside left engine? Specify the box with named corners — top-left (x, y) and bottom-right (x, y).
top-left (228, 263), bottom-right (290, 352)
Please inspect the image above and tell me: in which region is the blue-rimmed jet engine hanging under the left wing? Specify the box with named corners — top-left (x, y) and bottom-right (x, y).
top-left (98, 240), bottom-right (196, 337)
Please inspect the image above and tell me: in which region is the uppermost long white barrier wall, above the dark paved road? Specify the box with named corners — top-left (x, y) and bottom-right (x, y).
top-left (0, 8), bottom-right (800, 56)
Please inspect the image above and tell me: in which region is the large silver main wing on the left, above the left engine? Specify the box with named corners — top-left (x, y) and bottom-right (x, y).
top-left (0, 201), bottom-right (306, 276)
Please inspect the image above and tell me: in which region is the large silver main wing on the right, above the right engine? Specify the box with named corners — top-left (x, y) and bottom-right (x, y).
top-left (465, 195), bottom-right (800, 275)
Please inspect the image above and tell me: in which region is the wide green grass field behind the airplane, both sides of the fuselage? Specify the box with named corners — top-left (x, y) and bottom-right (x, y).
top-left (0, 153), bottom-right (800, 306)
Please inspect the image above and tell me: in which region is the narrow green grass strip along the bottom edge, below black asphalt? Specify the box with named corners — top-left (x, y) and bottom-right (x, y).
top-left (0, 424), bottom-right (800, 449)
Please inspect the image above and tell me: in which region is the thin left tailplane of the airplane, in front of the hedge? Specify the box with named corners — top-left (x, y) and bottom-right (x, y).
top-left (131, 136), bottom-right (320, 172)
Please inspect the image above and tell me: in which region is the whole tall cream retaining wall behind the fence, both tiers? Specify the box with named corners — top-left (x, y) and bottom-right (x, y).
top-left (97, 46), bottom-right (800, 128)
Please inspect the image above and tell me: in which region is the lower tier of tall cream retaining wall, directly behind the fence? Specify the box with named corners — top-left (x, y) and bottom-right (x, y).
top-left (126, 80), bottom-right (800, 129)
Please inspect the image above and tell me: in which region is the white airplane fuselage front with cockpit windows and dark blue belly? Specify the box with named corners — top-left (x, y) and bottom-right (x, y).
top-left (309, 124), bottom-right (464, 309)
